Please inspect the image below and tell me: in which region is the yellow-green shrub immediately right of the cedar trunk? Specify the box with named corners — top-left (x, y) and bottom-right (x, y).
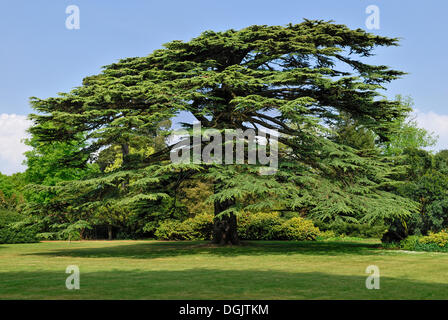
top-left (238, 212), bottom-right (284, 240)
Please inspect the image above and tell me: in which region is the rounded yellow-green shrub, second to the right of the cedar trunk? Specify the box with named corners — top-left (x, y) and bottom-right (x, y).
top-left (278, 217), bottom-right (321, 241)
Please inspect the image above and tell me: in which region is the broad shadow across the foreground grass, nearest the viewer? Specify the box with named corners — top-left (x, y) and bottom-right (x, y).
top-left (0, 265), bottom-right (448, 300)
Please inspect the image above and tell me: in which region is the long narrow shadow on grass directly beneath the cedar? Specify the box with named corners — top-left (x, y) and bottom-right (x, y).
top-left (22, 241), bottom-right (379, 259)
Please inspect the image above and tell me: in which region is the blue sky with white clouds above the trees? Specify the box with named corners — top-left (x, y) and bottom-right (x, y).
top-left (0, 0), bottom-right (448, 173)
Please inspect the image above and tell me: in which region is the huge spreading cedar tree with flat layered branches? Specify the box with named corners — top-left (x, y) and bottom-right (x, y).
top-left (30, 20), bottom-right (415, 243)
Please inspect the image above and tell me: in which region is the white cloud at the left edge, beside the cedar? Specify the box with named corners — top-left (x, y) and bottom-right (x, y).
top-left (0, 113), bottom-right (31, 174)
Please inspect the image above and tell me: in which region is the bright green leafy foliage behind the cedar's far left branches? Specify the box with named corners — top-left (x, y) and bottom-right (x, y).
top-left (22, 131), bottom-right (98, 236)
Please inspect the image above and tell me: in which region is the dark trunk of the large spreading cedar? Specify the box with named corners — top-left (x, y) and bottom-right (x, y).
top-left (213, 200), bottom-right (240, 245)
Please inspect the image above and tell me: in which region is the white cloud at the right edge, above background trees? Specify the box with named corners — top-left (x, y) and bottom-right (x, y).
top-left (415, 110), bottom-right (448, 150)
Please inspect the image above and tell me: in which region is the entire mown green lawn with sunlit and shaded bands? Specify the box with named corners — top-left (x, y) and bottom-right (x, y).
top-left (0, 240), bottom-right (448, 299)
